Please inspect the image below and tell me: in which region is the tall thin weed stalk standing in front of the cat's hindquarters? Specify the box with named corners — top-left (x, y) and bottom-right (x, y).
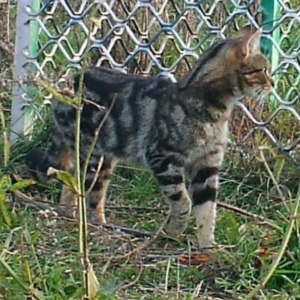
top-left (36, 1), bottom-right (106, 299)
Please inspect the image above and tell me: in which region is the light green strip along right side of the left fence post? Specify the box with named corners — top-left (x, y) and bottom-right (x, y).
top-left (24, 0), bottom-right (41, 135)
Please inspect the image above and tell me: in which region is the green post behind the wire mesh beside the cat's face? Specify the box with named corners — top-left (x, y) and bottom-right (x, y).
top-left (261, 0), bottom-right (281, 89)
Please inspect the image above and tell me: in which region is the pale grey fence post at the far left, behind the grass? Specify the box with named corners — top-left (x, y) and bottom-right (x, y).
top-left (10, 0), bottom-right (39, 143)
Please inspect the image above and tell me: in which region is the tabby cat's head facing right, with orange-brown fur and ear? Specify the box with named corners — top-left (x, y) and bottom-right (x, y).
top-left (226, 25), bottom-right (274, 100)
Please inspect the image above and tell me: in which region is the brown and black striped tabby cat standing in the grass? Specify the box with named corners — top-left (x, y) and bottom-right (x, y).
top-left (26, 26), bottom-right (274, 249)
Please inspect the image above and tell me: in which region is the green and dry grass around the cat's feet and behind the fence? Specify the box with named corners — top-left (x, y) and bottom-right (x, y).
top-left (0, 0), bottom-right (300, 300)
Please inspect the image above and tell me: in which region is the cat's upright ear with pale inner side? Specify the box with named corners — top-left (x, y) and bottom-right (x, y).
top-left (238, 28), bottom-right (262, 57)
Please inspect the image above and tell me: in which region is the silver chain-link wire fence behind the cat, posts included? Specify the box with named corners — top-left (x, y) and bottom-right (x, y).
top-left (12, 0), bottom-right (300, 163)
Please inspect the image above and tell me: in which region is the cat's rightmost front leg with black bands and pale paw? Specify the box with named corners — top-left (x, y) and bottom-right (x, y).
top-left (192, 167), bottom-right (219, 250)
